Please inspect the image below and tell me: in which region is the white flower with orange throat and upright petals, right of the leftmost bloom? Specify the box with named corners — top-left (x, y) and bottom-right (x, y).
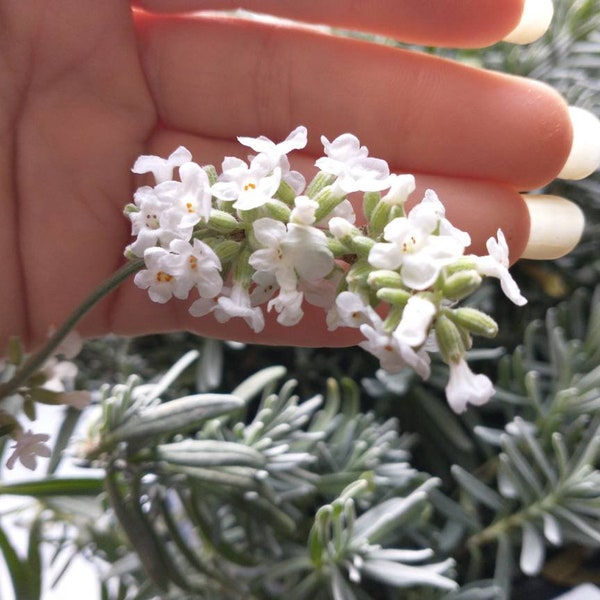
top-left (154, 162), bottom-right (212, 228)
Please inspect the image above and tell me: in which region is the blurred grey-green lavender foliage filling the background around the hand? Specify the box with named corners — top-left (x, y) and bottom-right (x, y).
top-left (0, 0), bottom-right (600, 600)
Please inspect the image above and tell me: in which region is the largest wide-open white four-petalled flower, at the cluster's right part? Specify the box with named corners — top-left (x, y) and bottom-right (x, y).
top-left (369, 198), bottom-right (464, 290)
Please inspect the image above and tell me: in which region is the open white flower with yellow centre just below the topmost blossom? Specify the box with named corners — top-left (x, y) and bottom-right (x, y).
top-left (211, 154), bottom-right (281, 210)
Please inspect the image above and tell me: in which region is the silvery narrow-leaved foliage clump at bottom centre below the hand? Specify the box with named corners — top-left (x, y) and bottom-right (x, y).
top-left (78, 357), bottom-right (457, 600)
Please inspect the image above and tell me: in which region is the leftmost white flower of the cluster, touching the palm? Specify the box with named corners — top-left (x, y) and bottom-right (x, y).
top-left (128, 186), bottom-right (193, 257)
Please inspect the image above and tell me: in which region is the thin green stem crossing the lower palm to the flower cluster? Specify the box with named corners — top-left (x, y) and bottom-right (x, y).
top-left (0, 258), bottom-right (144, 399)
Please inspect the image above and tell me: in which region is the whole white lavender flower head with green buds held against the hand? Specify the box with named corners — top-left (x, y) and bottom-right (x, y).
top-left (125, 126), bottom-right (526, 412)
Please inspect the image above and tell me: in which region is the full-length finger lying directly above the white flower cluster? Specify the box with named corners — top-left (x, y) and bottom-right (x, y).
top-left (136, 15), bottom-right (572, 190)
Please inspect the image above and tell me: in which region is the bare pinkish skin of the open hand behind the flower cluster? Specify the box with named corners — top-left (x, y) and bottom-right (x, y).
top-left (0, 0), bottom-right (572, 354)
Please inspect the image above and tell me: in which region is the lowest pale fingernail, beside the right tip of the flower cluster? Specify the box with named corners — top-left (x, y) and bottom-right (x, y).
top-left (522, 194), bottom-right (585, 260)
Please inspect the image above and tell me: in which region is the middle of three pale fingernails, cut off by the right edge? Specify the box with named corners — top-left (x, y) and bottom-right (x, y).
top-left (558, 106), bottom-right (600, 179)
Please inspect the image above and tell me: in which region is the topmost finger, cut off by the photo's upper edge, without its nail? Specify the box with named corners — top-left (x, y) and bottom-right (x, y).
top-left (133, 0), bottom-right (524, 48)
